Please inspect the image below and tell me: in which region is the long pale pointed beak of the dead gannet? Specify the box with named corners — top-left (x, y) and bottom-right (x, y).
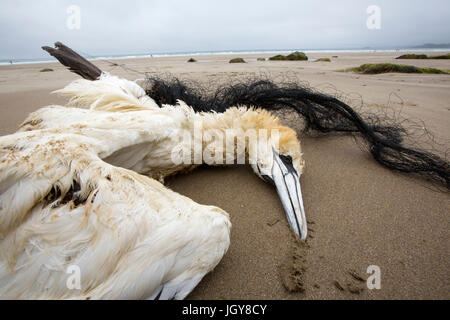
top-left (272, 152), bottom-right (307, 240)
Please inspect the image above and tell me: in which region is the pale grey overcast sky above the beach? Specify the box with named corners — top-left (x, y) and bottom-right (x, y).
top-left (0, 0), bottom-right (450, 59)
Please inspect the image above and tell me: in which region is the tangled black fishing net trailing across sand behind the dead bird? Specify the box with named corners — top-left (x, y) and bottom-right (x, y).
top-left (146, 75), bottom-right (450, 190)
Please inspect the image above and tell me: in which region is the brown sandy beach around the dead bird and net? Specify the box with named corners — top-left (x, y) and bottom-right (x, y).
top-left (0, 52), bottom-right (450, 299)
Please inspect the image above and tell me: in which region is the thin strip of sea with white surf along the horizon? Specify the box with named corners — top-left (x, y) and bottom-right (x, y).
top-left (0, 48), bottom-right (450, 66)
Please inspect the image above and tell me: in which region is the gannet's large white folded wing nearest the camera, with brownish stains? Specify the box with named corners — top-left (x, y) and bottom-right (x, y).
top-left (0, 118), bottom-right (230, 299)
